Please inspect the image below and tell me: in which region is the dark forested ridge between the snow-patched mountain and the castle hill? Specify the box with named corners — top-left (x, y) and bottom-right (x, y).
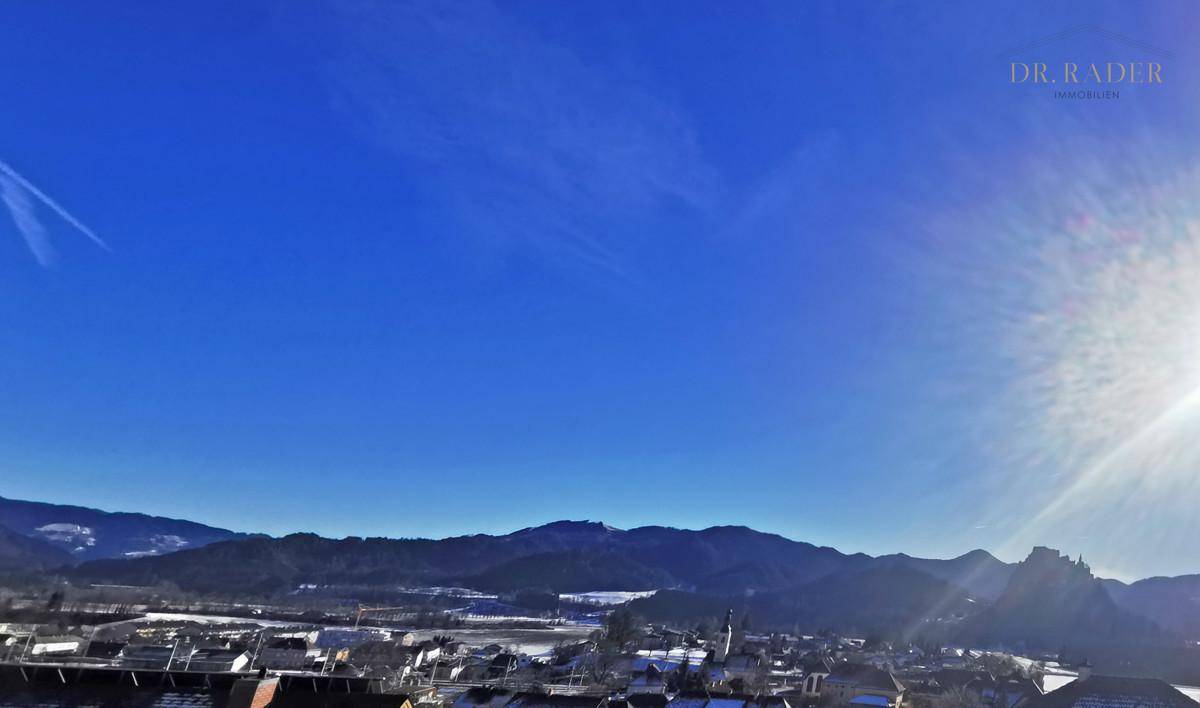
top-left (54, 521), bottom-right (1010, 599)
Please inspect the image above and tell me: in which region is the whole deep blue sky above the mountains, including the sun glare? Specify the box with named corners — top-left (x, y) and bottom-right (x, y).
top-left (0, 2), bottom-right (1200, 585)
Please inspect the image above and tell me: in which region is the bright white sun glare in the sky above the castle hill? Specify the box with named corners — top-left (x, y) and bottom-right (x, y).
top-left (912, 129), bottom-right (1200, 576)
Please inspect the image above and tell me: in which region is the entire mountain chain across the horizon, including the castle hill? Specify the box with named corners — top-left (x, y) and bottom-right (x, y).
top-left (0, 499), bottom-right (1200, 648)
